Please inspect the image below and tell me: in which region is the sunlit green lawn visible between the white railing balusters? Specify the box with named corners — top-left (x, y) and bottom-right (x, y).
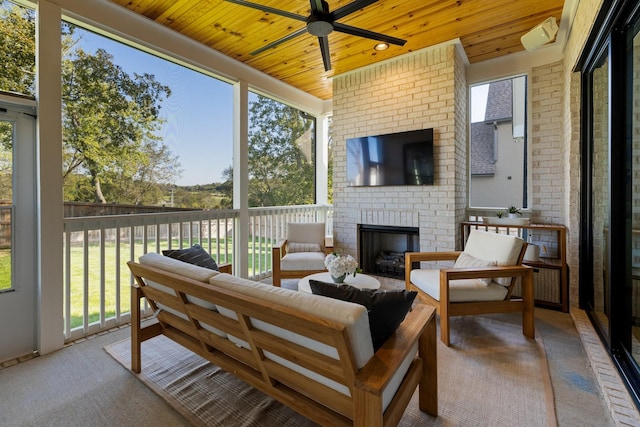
top-left (66, 239), bottom-right (271, 328)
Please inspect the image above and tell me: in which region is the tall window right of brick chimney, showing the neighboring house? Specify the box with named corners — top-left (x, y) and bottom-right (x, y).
top-left (469, 76), bottom-right (527, 209)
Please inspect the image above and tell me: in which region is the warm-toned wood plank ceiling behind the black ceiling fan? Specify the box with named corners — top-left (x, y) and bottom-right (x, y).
top-left (111, 0), bottom-right (564, 99)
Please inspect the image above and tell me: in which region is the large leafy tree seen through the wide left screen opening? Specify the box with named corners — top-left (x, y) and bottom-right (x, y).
top-left (62, 48), bottom-right (177, 203)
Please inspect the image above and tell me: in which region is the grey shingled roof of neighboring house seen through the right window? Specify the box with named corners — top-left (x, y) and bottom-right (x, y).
top-left (471, 79), bottom-right (513, 175)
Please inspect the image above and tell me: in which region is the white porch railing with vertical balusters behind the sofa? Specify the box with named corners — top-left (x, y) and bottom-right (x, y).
top-left (63, 205), bottom-right (333, 341)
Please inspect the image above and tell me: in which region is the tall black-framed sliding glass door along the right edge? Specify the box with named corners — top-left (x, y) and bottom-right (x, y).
top-left (579, 0), bottom-right (640, 407)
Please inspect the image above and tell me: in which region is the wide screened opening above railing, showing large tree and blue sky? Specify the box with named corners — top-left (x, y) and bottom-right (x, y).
top-left (62, 24), bottom-right (233, 209)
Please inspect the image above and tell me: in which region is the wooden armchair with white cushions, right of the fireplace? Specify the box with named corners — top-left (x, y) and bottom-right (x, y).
top-left (405, 230), bottom-right (535, 346)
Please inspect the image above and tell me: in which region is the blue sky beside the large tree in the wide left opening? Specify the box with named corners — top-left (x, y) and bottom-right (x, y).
top-left (75, 29), bottom-right (233, 185)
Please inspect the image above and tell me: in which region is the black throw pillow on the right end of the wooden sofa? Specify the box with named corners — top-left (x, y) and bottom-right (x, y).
top-left (309, 280), bottom-right (418, 351)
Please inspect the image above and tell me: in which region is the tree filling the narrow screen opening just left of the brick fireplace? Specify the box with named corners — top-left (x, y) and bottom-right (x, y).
top-left (248, 95), bottom-right (315, 206)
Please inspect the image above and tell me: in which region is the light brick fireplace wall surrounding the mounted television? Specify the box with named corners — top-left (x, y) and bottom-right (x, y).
top-left (333, 44), bottom-right (467, 256)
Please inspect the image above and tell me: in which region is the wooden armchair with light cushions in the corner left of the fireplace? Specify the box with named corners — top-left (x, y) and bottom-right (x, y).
top-left (271, 222), bottom-right (333, 286)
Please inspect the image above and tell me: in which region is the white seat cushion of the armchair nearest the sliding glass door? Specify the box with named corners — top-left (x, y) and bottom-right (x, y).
top-left (410, 269), bottom-right (507, 302)
